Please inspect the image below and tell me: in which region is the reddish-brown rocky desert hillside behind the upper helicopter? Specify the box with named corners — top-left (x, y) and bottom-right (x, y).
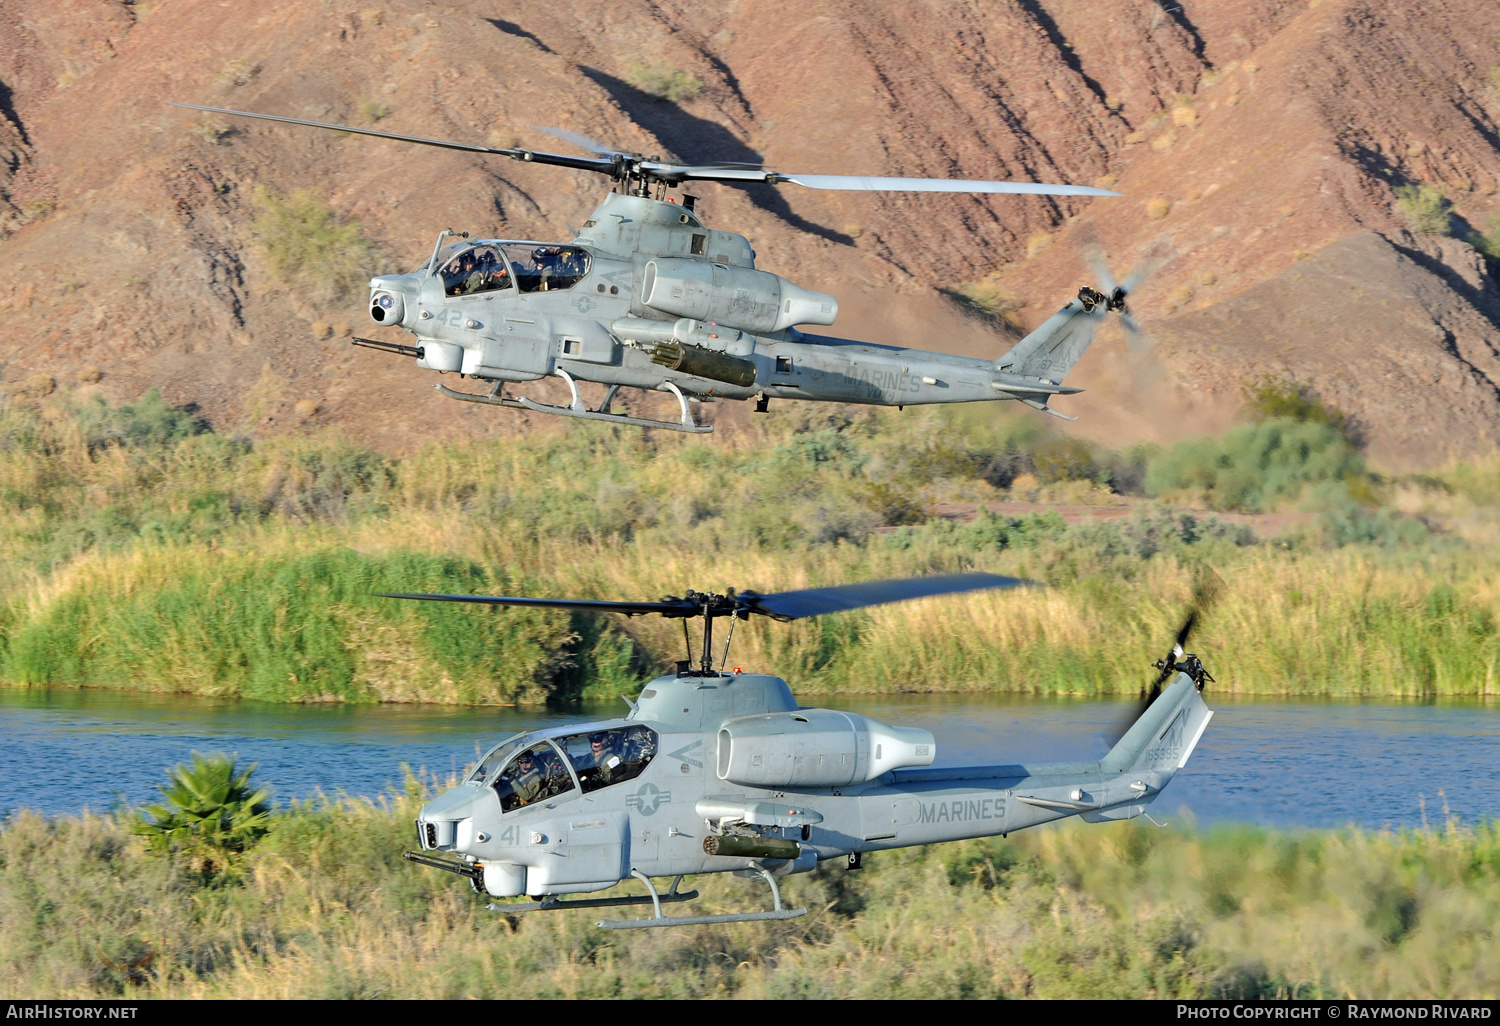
top-left (0, 0), bottom-right (1500, 465)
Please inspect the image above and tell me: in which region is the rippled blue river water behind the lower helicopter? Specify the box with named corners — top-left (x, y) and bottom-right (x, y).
top-left (0, 689), bottom-right (1500, 828)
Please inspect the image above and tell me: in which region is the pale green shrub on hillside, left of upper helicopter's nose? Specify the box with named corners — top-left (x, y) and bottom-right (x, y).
top-left (255, 188), bottom-right (375, 302)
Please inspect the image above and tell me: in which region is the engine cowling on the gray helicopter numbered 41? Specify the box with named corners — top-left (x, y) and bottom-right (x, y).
top-left (719, 710), bottom-right (938, 788)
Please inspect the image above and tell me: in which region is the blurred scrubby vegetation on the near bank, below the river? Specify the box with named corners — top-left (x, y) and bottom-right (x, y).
top-left (0, 780), bottom-right (1500, 1001)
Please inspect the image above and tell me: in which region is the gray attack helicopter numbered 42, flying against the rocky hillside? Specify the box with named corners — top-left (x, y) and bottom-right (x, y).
top-left (176, 104), bottom-right (1139, 434)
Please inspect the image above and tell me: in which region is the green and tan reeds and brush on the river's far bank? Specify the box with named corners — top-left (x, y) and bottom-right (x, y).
top-left (0, 383), bottom-right (1500, 704)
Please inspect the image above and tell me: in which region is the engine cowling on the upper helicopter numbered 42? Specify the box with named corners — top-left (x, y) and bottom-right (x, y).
top-left (641, 258), bottom-right (839, 332)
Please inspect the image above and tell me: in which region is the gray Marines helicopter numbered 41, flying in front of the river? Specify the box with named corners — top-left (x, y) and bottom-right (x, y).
top-left (386, 573), bottom-right (1214, 930)
